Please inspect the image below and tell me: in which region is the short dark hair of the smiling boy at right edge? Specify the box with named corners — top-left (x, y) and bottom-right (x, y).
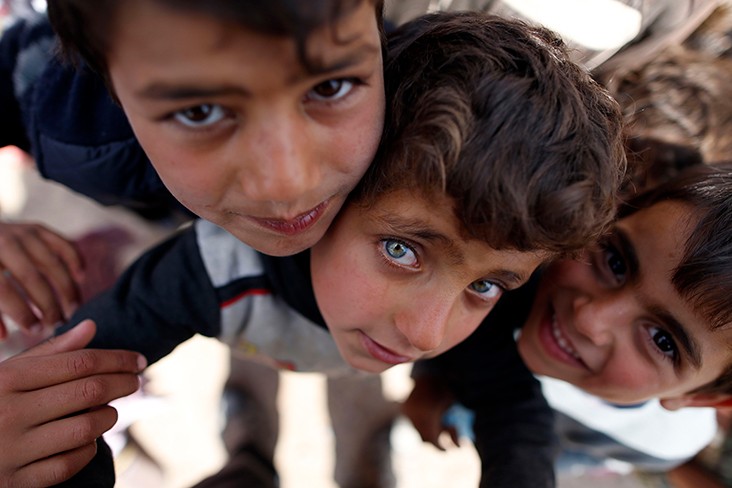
top-left (618, 164), bottom-right (732, 393)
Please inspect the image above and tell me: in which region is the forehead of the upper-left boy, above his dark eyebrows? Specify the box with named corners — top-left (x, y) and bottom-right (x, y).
top-left (108, 0), bottom-right (381, 74)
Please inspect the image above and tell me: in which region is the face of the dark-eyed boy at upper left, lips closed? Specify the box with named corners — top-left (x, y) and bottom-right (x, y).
top-left (108, 0), bottom-right (384, 255)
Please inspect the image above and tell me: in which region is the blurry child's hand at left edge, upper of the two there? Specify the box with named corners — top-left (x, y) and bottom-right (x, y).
top-left (0, 222), bottom-right (83, 340)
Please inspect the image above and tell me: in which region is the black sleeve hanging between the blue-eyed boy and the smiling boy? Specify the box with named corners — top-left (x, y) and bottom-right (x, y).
top-left (415, 292), bottom-right (558, 488)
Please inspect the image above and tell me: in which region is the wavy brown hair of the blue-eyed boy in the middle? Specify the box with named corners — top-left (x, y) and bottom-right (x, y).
top-left (352, 12), bottom-right (625, 253)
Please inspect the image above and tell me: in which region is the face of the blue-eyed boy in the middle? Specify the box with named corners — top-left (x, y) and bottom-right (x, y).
top-left (311, 190), bottom-right (547, 373)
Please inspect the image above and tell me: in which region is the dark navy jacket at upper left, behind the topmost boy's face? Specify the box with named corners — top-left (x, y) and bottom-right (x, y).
top-left (0, 15), bottom-right (183, 215)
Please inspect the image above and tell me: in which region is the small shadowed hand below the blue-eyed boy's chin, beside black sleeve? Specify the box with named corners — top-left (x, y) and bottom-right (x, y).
top-left (402, 376), bottom-right (460, 451)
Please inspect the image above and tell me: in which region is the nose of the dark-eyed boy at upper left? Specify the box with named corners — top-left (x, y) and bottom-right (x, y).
top-left (237, 107), bottom-right (322, 205)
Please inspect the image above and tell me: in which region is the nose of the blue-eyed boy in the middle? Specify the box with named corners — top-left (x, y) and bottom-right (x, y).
top-left (395, 293), bottom-right (455, 352)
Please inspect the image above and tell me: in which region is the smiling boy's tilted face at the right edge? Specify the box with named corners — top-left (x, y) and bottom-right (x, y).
top-left (519, 202), bottom-right (732, 406)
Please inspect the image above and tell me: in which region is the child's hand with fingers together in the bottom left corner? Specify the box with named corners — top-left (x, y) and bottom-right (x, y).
top-left (0, 321), bottom-right (145, 488)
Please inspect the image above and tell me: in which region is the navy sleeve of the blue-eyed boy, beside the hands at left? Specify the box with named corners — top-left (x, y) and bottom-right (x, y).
top-left (59, 226), bottom-right (220, 363)
